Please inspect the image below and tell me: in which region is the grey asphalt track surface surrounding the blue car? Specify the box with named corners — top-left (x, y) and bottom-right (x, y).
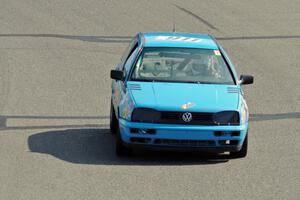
top-left (0, 0), bottom-right (300, 200)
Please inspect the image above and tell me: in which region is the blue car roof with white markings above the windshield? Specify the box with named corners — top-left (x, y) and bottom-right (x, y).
top-left (142, 32), bottom-right (218, 49)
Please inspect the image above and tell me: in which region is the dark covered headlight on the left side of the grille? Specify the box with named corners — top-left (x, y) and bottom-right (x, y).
top-left (131, 108), bottom-right (160, 123)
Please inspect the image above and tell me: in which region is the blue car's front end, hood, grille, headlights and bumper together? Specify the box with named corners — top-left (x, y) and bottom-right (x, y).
top-left (119, 82), bottom-right (248, 152)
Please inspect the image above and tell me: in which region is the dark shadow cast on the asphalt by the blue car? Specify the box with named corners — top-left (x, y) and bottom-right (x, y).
top-left (28, 128), bottom-right (228, 165)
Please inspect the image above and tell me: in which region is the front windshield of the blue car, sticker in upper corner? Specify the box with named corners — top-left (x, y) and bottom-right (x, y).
top-left (131, 47), bottom-right (234, 84)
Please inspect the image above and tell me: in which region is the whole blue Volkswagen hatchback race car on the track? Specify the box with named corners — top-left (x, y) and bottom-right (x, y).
top-left (110, 32), bottom-right (253, 157)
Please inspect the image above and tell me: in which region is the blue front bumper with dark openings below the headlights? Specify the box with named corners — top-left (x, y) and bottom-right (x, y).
top-left (119, 119), bottom-right (248, 152)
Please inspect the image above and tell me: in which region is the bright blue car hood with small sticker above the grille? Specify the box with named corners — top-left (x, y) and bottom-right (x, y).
top-left (127, 82), bottom-right (240, 112)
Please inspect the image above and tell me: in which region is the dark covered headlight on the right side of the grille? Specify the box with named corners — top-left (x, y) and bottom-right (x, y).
top-left (213, 111), bottom-right (240, 125)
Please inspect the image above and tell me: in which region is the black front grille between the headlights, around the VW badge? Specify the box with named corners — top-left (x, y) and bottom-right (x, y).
top-left (158, 111), bottom-right (216, 125)
